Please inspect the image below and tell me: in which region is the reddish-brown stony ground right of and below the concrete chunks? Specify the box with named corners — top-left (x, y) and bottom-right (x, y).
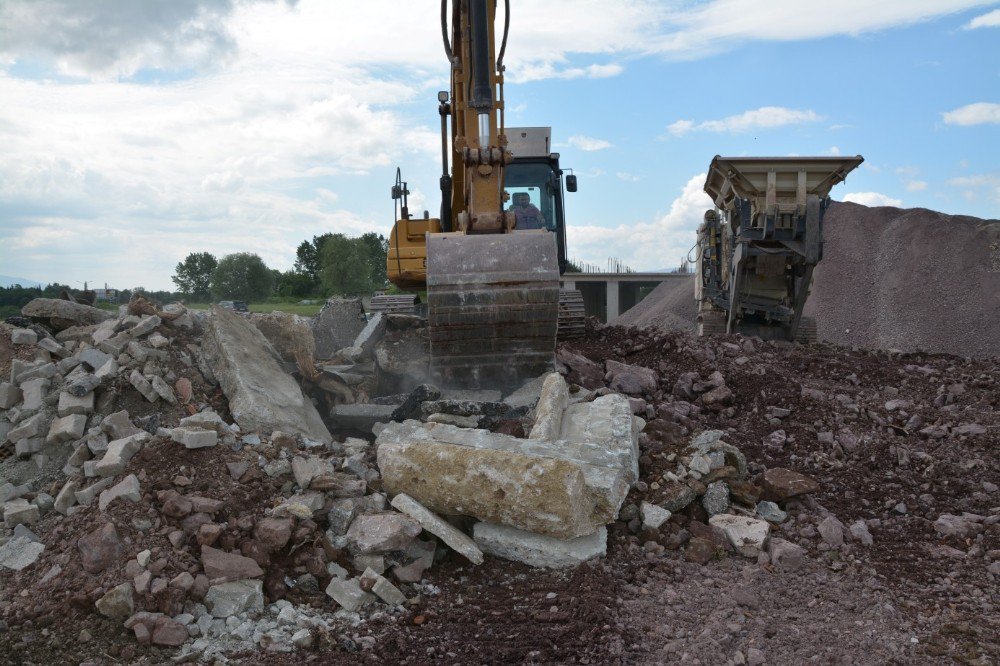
top-left (0, 320), bottom-right (1000, 664)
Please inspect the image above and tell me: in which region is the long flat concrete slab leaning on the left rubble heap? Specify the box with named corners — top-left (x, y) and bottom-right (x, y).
top-left (202, 306), bottom-right (333, 444)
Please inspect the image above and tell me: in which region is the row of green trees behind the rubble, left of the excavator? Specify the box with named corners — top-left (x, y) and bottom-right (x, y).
top-left (172, 233), bottom-right (389, 302)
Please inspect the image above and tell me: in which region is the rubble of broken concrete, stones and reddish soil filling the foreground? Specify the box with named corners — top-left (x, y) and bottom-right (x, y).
top-left (0, 299), bottom-right (1000, 663)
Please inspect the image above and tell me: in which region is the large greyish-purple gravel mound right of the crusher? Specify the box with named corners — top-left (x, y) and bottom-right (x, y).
top-left (806, 202), bottom-right (1000, 357)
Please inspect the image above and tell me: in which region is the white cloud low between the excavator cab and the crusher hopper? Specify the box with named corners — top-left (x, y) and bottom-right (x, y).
top-left (566, 174), bottom-right (712, 270)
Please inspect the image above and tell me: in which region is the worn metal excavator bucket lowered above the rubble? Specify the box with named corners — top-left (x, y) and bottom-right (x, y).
top-left (427, 231), bottom-right (559, 388)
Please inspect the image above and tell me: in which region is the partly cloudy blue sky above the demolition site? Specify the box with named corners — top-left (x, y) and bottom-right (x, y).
top-left (0, 0), bottom-right (1000, 288)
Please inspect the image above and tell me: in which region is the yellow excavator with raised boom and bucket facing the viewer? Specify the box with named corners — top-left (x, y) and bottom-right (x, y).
top-left (383, 0), bottom-right (583, 388)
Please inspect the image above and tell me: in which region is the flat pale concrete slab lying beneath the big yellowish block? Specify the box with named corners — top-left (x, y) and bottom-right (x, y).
top-left (473, 523), bottom-right (608, 569)
